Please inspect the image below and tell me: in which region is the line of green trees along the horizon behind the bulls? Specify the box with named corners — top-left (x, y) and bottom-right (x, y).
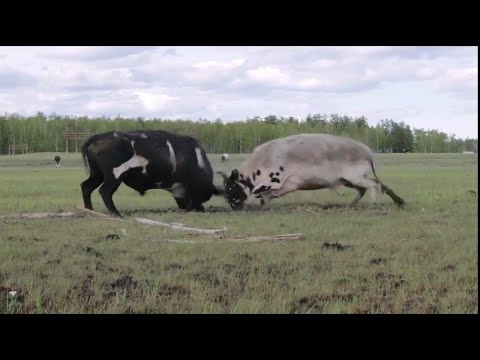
top-left (0, 113), bottom-right (478, 154)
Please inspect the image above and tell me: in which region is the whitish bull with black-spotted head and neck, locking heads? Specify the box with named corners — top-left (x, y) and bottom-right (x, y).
top-left (219, 134), bottom-right (405, 210)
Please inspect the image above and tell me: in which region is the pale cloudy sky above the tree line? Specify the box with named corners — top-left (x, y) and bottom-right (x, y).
top-left (0, 46), bottom-right (478, 138)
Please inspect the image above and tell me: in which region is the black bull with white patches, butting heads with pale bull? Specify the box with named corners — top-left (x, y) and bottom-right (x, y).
top-left (81, 130), bottom-right (223, 216)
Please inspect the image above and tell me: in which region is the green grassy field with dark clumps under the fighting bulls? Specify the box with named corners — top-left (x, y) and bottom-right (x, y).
top-left (0, 153), bottom-right (478, 313)
